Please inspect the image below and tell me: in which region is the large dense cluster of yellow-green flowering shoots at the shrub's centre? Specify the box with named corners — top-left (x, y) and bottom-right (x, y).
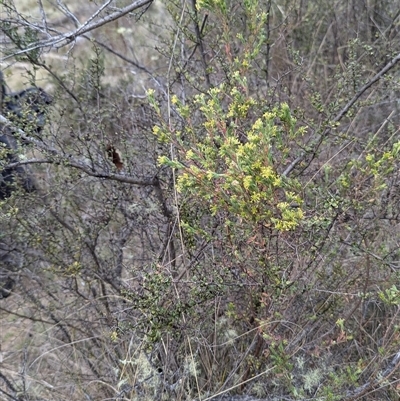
top-left (153, 71), bottom-right (303, 231)
